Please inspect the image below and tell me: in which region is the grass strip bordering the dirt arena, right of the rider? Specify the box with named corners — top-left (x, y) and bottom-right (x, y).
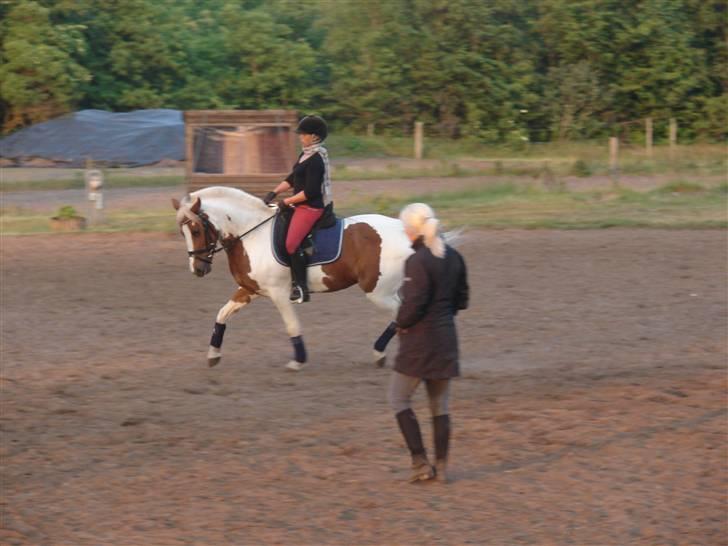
top-left (346, 182), bottom-right (728, 229)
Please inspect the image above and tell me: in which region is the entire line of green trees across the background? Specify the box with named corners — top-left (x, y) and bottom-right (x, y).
top-left (0, 0), bottom-right (728, 142)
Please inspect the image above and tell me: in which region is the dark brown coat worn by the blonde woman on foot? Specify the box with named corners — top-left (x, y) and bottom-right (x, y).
top-left (394, 239), bottom-right (468, 379)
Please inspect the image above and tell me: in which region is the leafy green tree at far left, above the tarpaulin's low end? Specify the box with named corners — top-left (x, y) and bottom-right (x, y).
top-left (0, 0), bottom-right (90, 131)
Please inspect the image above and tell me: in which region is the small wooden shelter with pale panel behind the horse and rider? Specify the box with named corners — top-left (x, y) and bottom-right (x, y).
top-left (184, 110), bottom-right (298, 196)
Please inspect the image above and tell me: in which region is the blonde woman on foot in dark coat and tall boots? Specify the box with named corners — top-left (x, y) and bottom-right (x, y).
top-left (389, 203), bottom-right (469, 482)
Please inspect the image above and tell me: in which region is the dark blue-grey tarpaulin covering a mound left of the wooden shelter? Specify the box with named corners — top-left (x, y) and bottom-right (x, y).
top-left (0, 110), bottom-right (185, 166)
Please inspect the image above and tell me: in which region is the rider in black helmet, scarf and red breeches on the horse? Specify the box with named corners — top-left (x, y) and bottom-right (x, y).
top-left (264, 116), bottom-right (332, 303)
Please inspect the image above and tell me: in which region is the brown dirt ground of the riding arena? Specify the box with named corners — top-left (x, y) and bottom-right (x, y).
top-left (0, 230), bottom-right (728, 546)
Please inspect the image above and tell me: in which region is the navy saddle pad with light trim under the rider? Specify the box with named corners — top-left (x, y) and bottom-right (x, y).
top-left (271, 214), bottom-right (344, 267)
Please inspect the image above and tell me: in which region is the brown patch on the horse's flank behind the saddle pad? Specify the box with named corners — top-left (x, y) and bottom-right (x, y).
top-left (321, 223), bottom-right (382, 294)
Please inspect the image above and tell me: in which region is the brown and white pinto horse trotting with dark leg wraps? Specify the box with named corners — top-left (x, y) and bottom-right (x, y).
top-left (172, 187), bottom-right (413, 371)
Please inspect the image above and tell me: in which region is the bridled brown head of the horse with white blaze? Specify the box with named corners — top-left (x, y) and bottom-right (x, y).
top-left (172, 197), bottom-right (220, 277)
